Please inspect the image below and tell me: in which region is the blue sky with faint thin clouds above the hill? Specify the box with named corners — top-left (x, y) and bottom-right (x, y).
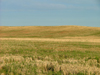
top-left (0, 0), bottom-right (100, 27)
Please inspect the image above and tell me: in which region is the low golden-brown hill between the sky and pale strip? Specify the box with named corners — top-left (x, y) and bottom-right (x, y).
top-left (0, 26), bottom-right (100, 38)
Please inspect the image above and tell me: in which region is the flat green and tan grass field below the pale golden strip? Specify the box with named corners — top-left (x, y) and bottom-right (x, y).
top-left (0, 40), bottom-right (100, 75)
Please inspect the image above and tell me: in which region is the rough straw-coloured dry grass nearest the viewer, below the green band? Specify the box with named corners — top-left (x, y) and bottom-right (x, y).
top-left (0, 55), bottom-right (100, 75)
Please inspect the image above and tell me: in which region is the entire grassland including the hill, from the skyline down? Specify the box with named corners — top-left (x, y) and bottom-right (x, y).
top-left (0, 26), bottom-right (100, 75)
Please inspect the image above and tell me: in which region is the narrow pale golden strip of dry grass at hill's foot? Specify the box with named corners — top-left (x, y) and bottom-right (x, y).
top-left (0, 37), bottom-right (100, 42)
